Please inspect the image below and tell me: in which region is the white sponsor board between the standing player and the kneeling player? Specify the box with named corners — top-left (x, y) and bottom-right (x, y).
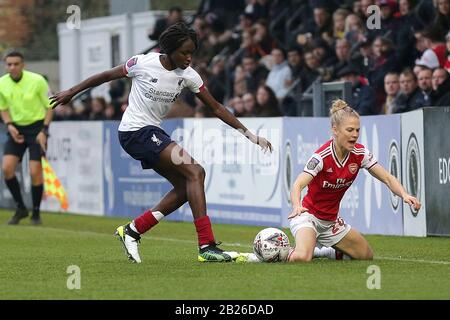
top-left (180, 118), bottom-right (283, 225)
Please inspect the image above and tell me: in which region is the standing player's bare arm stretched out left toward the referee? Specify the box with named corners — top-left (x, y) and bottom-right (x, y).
top-left (50, 65), bottom-right (126, 109)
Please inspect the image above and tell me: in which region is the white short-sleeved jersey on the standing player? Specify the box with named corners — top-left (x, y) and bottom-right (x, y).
top-left (119, 52), bottom-right (203, 131)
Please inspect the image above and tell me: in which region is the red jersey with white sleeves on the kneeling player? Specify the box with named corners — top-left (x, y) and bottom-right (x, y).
top-left (302, 140), bottom-right (377, 221)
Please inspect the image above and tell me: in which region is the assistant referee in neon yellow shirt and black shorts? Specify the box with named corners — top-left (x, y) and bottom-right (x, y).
top-left (0, 52), bottom-right (53, 225)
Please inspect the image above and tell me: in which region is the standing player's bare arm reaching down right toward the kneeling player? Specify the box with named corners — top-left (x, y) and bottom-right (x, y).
top-left (197, 88), bottom-right (273, 152)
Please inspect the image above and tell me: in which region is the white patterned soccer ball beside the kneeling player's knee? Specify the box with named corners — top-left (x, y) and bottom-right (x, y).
top-left (253, 228), bottom-right (290, 262)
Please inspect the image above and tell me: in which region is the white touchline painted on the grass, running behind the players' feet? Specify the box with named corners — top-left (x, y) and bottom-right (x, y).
top-left (6, 226), bottom-right (450, 265)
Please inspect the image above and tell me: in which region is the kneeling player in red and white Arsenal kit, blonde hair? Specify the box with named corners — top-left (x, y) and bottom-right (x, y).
top-left (288, 100), bottom-right (421, 262)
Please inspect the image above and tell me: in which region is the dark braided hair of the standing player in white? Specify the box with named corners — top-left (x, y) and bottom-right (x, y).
top-left (159, 22), bottom-right (198, 55)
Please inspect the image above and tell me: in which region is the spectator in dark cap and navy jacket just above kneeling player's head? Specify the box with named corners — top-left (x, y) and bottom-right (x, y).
top-left (338, 66), bottom-right (379, 115)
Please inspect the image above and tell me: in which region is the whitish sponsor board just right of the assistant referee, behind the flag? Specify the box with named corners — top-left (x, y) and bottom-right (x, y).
top-left (41, 121), bottom-right (104, 215)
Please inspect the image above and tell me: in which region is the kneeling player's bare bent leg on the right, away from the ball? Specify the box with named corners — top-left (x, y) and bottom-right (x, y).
top-left (334, 228), bottom-right (373, 260)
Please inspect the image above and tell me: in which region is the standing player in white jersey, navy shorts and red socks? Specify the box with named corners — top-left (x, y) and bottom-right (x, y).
top-left (51, 23), bottom-right (272, 263)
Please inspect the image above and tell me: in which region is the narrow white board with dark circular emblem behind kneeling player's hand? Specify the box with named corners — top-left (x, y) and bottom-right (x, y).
top-left (402, 110), bottom-right (427, 237)
